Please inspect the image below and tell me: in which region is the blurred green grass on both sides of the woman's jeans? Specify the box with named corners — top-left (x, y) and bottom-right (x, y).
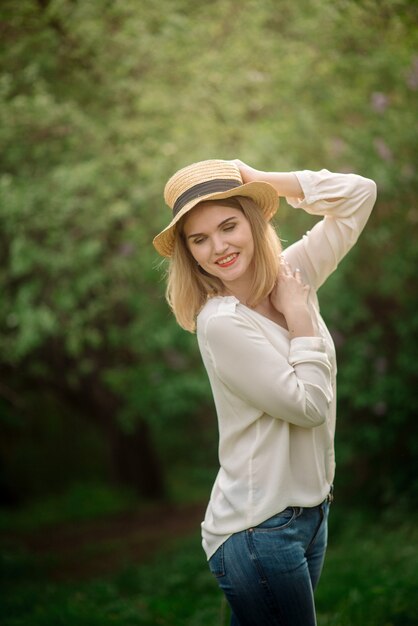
top-left (0, 505), bottom-right (418, 626)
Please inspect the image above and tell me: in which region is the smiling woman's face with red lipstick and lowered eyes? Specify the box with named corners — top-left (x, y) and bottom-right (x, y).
top-left (183, 200), bottom-right (254, 287)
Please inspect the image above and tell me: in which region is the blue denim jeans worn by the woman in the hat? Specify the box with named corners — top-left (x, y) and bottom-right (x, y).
top-left (209, 501), bottom-right (329, 626)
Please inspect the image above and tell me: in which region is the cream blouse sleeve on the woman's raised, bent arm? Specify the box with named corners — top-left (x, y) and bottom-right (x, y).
top-left (284, 169), bottom-right (376, 289)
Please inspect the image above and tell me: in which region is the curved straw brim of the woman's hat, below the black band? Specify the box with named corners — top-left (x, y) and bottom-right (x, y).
top-left (152, 181), bottom-right (279, 257)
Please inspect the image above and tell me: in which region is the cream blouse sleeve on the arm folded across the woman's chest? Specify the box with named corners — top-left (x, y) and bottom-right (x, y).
top-left (199, 304), bottom-right (333, 428)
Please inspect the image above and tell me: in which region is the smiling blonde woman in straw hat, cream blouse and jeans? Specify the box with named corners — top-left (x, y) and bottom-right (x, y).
top-left (154, 160), bottom-right (376, 626)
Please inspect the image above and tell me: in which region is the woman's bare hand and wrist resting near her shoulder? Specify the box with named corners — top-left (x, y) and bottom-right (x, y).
top-left (270, 260), bottom-right (316, 338)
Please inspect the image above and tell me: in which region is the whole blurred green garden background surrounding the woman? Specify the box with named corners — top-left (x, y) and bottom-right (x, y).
top-left (0, 0), bottom-right (418, 626)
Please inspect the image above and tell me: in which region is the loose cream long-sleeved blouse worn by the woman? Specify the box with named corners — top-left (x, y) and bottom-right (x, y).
top-left (197, 170), bottom-right (376, 559)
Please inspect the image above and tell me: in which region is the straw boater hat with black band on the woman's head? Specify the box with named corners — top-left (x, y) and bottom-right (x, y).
top-left (153, 159), bottom-right (279, 257)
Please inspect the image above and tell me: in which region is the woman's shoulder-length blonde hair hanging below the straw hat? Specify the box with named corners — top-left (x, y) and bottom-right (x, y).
top-left (166, 196), bottom-right (282, 332)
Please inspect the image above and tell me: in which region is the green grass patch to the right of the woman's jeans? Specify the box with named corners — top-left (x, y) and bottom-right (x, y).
top-left (316, 513), bottom-right (418, 626)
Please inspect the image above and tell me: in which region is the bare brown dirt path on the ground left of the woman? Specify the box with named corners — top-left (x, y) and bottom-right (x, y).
top-left (2, 504), bottom-right (205, 581)
